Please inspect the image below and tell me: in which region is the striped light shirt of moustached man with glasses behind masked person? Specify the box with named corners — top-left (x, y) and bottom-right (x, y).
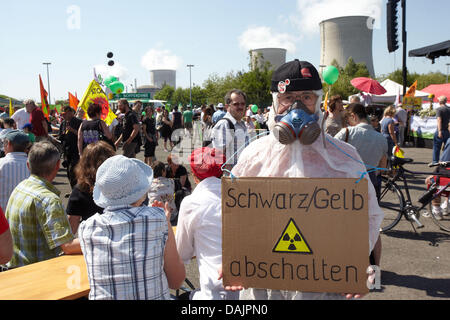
top-left (211, 112), bottom-right (250, 166)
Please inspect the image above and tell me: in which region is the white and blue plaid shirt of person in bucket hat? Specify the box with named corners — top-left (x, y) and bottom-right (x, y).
top-left (78, 206), bottom-right (170, 300)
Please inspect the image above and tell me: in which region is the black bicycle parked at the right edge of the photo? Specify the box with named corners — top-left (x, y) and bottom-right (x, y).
top-left (379, 156), bottom-right (450, 232)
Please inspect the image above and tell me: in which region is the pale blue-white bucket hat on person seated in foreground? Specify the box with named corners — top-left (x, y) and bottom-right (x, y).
top-left (93, 155), bottom-right (153, 208)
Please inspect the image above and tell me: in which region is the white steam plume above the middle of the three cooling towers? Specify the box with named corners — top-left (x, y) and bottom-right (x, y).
top-left (239, 27), bottom-right (296, 52)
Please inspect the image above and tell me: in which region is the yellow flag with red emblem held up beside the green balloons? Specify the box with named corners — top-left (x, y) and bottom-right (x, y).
top-left (78, 80), bottom-right (117, 126)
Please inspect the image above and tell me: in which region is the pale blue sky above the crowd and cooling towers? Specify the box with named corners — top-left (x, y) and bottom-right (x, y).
top-left (0, 0), bottom-right (450, 101)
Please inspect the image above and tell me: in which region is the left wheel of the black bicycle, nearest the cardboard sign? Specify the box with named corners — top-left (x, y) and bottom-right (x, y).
top-left (378, 177), bottom-right (405, 232)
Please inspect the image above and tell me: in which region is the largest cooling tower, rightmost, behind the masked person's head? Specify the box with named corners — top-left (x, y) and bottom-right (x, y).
top-left (320, 16), bottom-right (375, 77)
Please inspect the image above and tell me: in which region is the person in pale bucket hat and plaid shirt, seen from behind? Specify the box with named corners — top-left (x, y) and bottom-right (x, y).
top-left (79, 155), bottom-right (185, 300)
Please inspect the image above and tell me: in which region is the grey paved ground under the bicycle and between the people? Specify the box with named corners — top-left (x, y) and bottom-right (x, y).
top-left (55, 134), bottom-right (450, 300)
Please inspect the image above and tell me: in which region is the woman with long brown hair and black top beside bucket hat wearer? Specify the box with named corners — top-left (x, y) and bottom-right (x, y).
top-left (66, 141), bottom-right (116, 234)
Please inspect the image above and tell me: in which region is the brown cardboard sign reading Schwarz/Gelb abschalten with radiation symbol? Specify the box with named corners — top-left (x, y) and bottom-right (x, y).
top-left (222, 178), bottom-right (369, 293)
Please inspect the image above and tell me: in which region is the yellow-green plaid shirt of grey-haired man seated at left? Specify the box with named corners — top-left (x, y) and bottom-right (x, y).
top-left (6, 175), bottom-right (74, 268)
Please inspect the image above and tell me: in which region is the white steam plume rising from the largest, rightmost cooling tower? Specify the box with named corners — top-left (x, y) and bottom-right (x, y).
top-left (290, 0), bottom-right (383, 36)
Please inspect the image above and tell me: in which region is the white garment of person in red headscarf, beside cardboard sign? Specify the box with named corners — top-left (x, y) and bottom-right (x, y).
top-left (175, 177), bottom-right (239, 300)
